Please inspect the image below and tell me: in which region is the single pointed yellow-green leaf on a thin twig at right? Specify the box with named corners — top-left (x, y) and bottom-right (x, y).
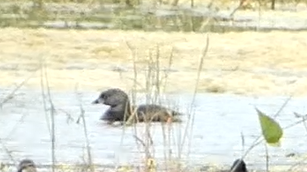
top-left (256, 108), bottom-right (283, 146)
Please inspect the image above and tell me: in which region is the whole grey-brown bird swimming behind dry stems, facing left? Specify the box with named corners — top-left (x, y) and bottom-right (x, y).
top-left (92, 88), bottom-right (181, 123)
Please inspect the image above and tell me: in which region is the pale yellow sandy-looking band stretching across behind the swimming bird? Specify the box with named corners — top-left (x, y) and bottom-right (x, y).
top-left (0, 28), bottom-right (307, 96)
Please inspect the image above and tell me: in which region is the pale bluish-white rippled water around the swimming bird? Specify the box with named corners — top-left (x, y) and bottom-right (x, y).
top-left (0, 88), bottom-right (307, 171)
